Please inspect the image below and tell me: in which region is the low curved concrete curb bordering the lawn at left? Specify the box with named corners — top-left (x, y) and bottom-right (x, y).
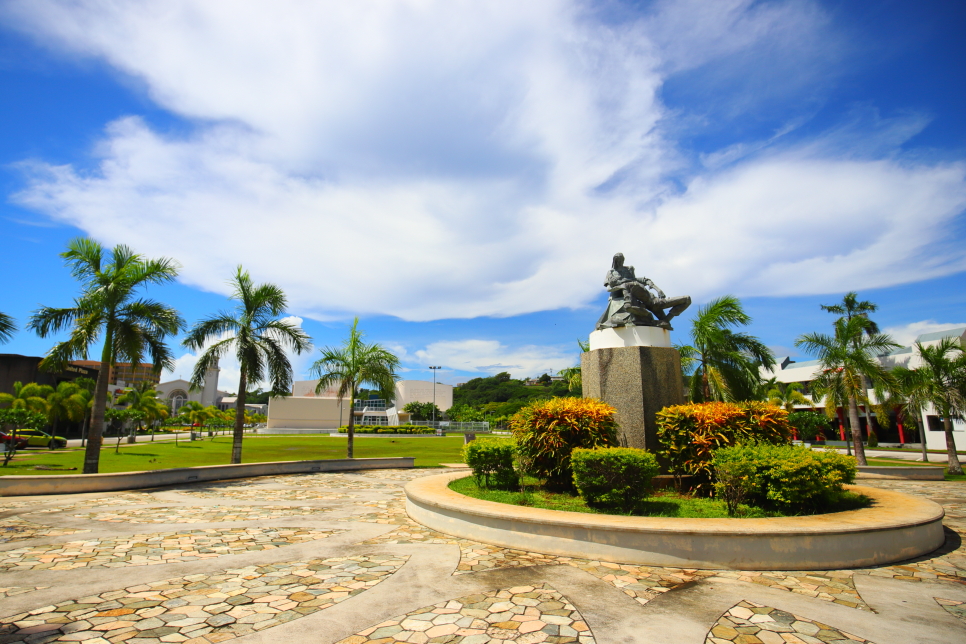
top-left (0, 456), bottom-right (415, 496)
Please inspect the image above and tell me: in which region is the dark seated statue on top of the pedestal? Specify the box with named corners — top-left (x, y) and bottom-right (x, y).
top-left (597, 253), bottom-right (691, 331)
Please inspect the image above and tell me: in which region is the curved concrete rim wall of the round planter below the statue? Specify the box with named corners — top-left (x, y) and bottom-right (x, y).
top-left (406, 472), bottom-right (945, 570)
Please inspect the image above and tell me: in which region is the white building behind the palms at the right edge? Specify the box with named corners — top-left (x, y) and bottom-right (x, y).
top-left (761, 327), bottom-right (966, 449)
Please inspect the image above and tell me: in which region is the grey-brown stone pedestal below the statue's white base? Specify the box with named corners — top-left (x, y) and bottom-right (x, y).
top-left (580, 346), bottom-right (684, 451)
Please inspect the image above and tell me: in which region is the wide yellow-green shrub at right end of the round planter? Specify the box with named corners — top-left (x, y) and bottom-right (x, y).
top-left (713, 444), bottom-right (856, 513)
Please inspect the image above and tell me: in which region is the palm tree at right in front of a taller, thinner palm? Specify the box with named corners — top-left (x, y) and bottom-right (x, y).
top-left (795, 315), bottom-right (899, 465)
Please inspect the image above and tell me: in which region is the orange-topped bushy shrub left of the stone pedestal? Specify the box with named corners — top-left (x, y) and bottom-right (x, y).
top-left (510, 398), bottom-right (617, 490)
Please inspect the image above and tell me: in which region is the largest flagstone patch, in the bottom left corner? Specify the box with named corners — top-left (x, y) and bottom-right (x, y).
top-left (0, 555), bottom-right (406, 644)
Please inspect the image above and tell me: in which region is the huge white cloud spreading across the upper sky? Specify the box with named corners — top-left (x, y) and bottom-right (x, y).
top-left (5, 0), bottom-right (966, 322)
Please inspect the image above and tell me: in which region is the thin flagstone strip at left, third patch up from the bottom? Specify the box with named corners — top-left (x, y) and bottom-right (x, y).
top-left (74, 505), bottom-right (328, 523)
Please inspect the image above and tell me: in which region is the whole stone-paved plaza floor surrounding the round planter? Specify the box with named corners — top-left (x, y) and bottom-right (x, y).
top-left (0, 469), bottom-right (966, 644)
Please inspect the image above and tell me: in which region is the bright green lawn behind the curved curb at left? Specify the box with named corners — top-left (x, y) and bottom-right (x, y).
top-left (0, 435), bottom-right (463, 475)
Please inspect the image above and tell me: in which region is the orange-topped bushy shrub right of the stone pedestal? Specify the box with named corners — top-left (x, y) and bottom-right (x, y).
top-left (657, 401), bottom-right (791, 495)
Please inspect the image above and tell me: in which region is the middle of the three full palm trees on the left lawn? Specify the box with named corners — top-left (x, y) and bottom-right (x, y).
top-left (184, 266), bottom-right (312, 463)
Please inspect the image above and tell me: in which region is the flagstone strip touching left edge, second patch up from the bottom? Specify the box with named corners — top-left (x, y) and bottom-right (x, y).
top-left (0, 528), bottom-right (338, 573)
